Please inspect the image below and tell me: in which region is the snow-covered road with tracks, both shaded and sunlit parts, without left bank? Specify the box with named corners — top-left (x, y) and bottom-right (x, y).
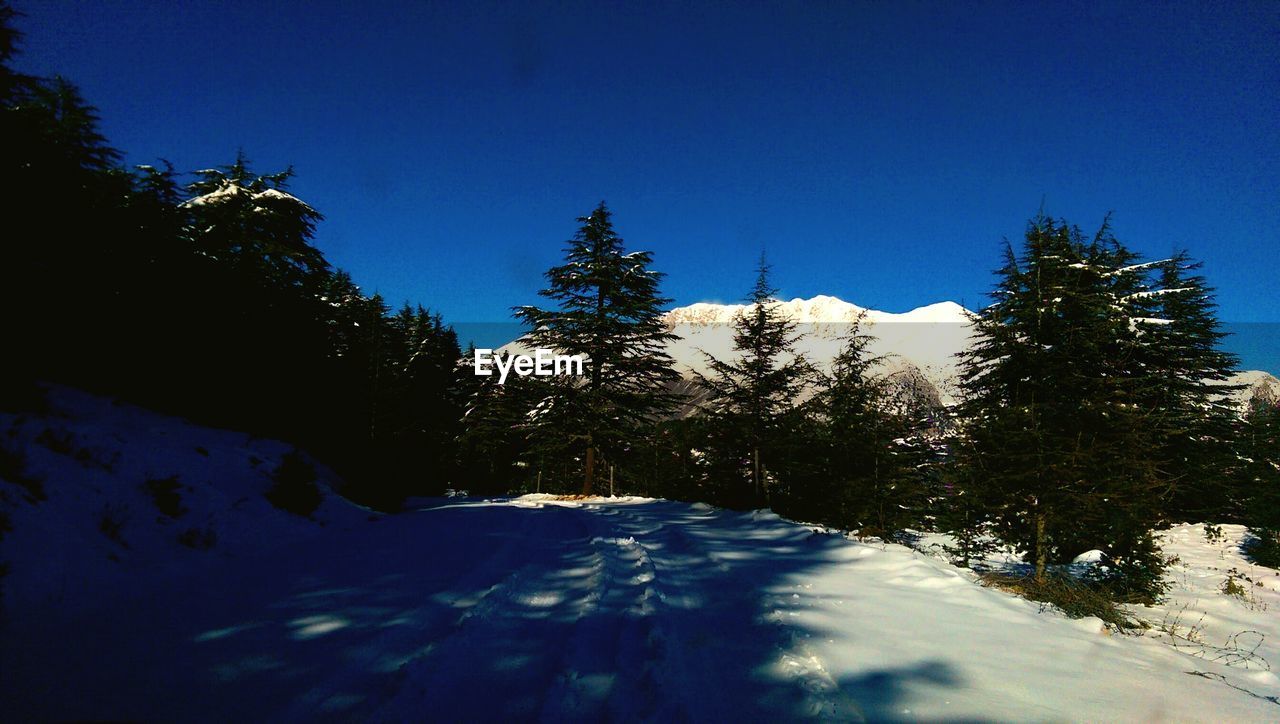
top-left (0, 499), bottom-right (1280, 721)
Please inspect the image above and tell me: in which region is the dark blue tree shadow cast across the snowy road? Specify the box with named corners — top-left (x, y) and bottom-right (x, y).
top-left (0, 501), bottom-right (961, 721)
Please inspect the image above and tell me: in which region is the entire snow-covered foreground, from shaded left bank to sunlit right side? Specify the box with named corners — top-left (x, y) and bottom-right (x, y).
top-left (0, 388), bottom-right (1280, 721)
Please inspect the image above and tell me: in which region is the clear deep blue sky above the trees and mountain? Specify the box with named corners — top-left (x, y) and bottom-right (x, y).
top-left (14, 0), bottom-right (1280, 366)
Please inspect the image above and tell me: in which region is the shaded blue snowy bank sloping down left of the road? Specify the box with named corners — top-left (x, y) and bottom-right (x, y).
top-left (0, 386), bottom-right (369, 611)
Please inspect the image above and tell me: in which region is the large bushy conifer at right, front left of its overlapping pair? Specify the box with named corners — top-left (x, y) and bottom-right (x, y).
top-left (957, 217), bottom-right (1162, 594)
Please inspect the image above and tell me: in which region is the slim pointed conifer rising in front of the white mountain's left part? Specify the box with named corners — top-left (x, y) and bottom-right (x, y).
top-left (698, 255), bottom-right (813, 508)
